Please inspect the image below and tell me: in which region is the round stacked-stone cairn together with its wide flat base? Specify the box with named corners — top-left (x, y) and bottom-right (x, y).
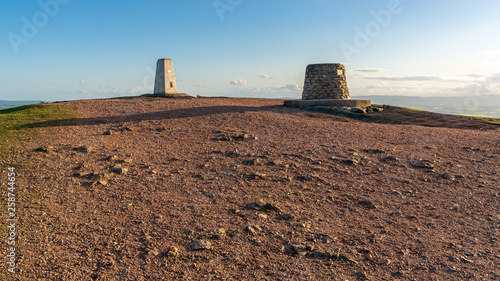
top-left (284, 63), bottom-right (371, 107)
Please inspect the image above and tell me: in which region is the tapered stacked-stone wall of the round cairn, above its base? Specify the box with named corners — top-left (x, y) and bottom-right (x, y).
top-left (302, 64), bottom-right (351, 100)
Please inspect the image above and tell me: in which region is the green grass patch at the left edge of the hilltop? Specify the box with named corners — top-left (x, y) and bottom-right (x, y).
top-left (0, 104), bottom-right (77, 159)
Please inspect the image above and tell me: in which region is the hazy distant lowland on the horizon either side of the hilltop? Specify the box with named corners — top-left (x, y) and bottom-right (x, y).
top-left (0, 95), bottom-right (500, 118)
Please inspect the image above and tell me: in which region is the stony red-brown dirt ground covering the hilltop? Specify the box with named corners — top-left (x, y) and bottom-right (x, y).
top-left (1, 98), bottom-right (500, 280)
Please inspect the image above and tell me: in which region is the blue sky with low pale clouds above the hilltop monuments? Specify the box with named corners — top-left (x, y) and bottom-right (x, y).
top-left (0, 0), bottom-right (500, 101)
